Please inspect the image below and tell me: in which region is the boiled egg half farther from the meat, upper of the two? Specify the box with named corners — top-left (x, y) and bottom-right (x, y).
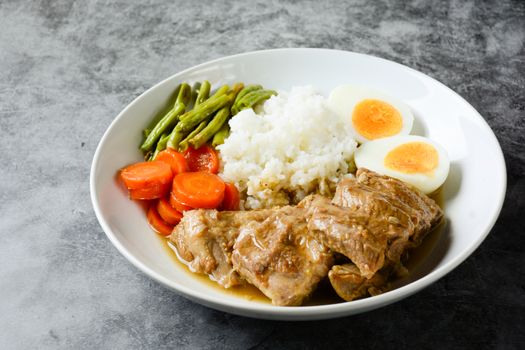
top-left (328, 85), bottom-right (414, 143)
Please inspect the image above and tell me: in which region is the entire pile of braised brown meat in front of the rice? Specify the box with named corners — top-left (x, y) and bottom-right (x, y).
top-left (170, 169), bottom-right (443, 305)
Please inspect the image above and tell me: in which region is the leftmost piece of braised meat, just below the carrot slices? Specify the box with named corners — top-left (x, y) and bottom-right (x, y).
top-left (170, 209), bottom-right (272, 288)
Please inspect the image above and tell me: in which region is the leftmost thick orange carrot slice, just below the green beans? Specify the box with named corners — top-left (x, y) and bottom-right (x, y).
top-left (120, 161), bottom-right (173, 189)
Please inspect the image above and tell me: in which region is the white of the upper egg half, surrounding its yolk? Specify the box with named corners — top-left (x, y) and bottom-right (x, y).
top-left (328, 85), bottom-right (414, 143)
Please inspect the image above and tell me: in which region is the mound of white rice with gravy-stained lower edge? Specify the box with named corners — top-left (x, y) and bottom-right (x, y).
top-left (217, 86), bottom-right (357, 209)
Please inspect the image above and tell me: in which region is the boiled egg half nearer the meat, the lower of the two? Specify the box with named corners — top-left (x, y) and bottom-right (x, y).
top-left (354, 135), bottom-right (450, 194)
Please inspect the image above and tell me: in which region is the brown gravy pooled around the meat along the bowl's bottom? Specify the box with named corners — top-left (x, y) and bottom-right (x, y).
top-left (158, 190), bottom-right (443, 306)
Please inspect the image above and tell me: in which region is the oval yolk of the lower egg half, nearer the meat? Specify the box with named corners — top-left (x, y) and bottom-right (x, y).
top-left (384, 142), bottom-right (439, 174)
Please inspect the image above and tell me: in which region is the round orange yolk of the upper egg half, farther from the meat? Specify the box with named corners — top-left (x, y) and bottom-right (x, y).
top-left (352, 100), bottom-right (403, 140)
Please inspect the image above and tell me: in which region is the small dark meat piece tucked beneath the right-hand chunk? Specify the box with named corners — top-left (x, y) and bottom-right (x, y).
top-left (328, 264), bottom-right (389, 301)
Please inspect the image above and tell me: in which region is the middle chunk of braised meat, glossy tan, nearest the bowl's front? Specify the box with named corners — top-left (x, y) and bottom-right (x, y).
top-left (232, 206), bottom-right (333, 306)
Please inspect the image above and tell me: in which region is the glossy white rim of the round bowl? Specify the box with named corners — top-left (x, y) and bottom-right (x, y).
top-left (90, 48), bottom-right (507, 320)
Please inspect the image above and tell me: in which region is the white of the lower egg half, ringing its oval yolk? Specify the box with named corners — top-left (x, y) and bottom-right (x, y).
top-left (354, 135), bottom-right (450, 194)
